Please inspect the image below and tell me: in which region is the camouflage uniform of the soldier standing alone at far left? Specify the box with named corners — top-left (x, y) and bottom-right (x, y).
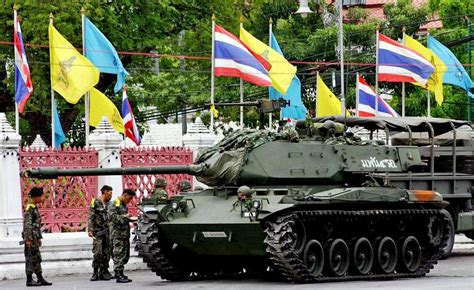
top-left (23, 203), bottom-right (43, 275)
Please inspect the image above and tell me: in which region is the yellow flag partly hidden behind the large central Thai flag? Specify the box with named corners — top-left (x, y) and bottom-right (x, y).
top-left (240, 27), bottom-right (296, 95)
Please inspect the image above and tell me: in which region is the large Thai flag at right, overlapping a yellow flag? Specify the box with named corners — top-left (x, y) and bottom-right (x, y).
top-left (378, 34), bottom-right (434, 85)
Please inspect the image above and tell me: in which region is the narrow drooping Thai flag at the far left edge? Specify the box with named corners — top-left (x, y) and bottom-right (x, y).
top-left (13, 17), bottom-right (33, 113)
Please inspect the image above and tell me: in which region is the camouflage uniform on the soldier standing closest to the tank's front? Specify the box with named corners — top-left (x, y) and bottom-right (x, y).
top-left (107, 198), bottom-right (130, 272)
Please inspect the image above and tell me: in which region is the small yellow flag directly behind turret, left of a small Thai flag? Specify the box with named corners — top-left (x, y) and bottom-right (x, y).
top-left (316, 74), bottom-right (347, 117)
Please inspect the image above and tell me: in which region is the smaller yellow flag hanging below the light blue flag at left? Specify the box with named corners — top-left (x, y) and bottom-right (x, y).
top-left (89, 88), bottom-right (125, 133)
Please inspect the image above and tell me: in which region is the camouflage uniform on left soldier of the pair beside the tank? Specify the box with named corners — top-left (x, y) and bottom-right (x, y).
top-left (87, 199), bottom-right (110, 270)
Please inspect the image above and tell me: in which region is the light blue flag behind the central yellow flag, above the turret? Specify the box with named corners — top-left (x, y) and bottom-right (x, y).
top-left (268, 33), bottom-right (308, 120)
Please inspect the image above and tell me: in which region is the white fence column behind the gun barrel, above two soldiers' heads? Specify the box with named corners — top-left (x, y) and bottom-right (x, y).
top-left (89, 117), bottom-right (123, 198)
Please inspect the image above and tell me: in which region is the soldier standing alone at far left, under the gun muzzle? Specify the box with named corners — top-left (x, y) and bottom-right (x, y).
top-left (22, 187), bottom-right (53, 286)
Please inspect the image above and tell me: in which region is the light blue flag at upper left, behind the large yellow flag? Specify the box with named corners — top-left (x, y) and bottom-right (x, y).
top-left (84, 17), bottom-right (128, 93)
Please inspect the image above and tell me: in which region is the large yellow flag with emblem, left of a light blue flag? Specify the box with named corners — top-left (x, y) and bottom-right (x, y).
top-left (48, 24), bottom-right (99, 104)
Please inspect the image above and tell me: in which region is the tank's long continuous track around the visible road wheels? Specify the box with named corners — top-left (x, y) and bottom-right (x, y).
top-left (264, 209), bottom-right (451, 283)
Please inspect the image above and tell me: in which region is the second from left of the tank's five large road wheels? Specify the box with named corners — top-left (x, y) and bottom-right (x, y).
top-left (327, 239), bottom-right (349, 277)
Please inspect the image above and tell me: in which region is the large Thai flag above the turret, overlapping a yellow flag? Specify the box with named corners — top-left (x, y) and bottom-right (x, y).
top-left (214, 25), bottom-right (272, 87)
